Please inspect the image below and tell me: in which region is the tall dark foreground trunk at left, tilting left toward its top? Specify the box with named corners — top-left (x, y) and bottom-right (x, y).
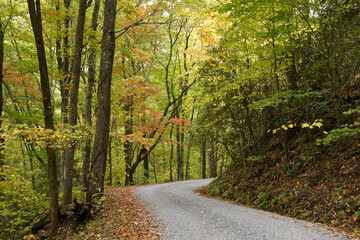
top-left (27, 0), bottom-right (59, 234)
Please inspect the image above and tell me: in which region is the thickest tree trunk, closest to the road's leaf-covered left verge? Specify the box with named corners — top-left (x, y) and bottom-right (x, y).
top-left (86, 0), bottom-right (117, 202)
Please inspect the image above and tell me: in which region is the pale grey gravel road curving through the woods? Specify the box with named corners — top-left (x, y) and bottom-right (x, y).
top-left (136, 179), bottom-right (346, 240)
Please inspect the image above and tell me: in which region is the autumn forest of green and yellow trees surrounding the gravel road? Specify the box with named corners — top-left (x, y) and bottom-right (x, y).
top-left (0, 0), bottom-right (360, 239)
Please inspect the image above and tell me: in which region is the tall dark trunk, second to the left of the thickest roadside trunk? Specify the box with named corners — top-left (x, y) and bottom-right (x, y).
top-left (63, 0), bottom-right (87, 205)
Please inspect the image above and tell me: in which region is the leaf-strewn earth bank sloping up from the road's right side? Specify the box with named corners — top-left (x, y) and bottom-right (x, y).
top-left (206, 132), bottom-right (360, 237)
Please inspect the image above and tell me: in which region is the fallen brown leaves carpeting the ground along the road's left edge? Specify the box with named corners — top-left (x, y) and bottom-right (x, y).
top-left (54, 187), bottom-right (161, 240)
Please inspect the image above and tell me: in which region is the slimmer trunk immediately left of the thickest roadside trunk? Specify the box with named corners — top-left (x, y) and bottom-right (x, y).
top-left (82, 0), bottom-right (100, 193)
